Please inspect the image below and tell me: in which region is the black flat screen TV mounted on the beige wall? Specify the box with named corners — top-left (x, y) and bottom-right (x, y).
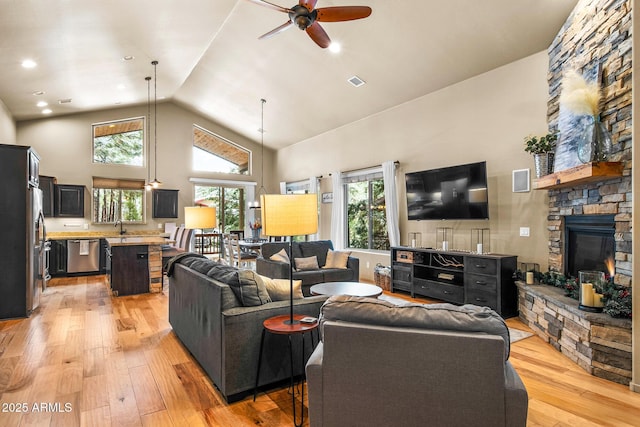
top-left (405, 162), bottom-right (489, 220)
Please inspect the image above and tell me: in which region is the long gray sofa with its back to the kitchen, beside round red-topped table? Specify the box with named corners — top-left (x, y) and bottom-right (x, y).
top-left (168, 254), bottom-right (326, 402)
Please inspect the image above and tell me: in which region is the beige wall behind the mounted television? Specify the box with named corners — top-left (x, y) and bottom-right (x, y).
top-left (276, 52), bottom-right (549, 279)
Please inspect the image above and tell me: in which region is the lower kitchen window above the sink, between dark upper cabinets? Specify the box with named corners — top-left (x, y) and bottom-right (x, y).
top-left (93, 177), bottom-right (145, 224)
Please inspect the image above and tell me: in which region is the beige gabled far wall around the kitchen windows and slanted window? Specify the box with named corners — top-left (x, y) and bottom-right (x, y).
top-left (17, 102), bottom-right (277, 231)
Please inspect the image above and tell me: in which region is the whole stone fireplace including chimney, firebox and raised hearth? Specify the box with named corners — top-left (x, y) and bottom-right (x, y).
top-left (518, 0), bottom-right (633, 384)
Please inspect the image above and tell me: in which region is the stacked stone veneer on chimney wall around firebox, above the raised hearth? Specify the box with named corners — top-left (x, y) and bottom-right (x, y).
top-left (547, 0), bottom-right (632, 286)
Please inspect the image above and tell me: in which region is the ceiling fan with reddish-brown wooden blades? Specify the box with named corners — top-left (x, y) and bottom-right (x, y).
top-left (249, 0), bottom-right (371, 48)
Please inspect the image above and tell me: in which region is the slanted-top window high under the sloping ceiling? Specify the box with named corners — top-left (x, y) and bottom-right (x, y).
top-left (193, 125), bottom-right (250, 175)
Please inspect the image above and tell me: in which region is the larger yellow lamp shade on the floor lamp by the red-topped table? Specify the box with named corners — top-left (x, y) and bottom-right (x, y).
top-left (260, 194), bottom-right (318, 236)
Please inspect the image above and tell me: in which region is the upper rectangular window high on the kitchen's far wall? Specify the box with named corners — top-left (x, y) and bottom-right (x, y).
top-left (92, 117), bottom-right (144, 166)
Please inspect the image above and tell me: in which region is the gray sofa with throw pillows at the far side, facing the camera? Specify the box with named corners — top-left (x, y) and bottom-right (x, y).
top-left (256, 240), bottom-right (360, 296)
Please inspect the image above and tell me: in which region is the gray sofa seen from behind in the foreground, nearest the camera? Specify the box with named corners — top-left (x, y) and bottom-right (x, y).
top-left (306, 296), bottom-right (528, 427)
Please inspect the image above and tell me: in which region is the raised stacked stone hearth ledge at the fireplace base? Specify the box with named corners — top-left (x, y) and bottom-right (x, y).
top-left (517, 282), bottom-right (632, 384)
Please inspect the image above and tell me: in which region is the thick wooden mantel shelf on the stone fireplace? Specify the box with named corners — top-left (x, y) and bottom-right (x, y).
top-left (533, 162), bottom-right (624, 190)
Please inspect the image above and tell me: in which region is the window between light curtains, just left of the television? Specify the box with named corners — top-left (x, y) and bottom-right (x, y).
top-left (343, 169), bottom-right (389, 250)
